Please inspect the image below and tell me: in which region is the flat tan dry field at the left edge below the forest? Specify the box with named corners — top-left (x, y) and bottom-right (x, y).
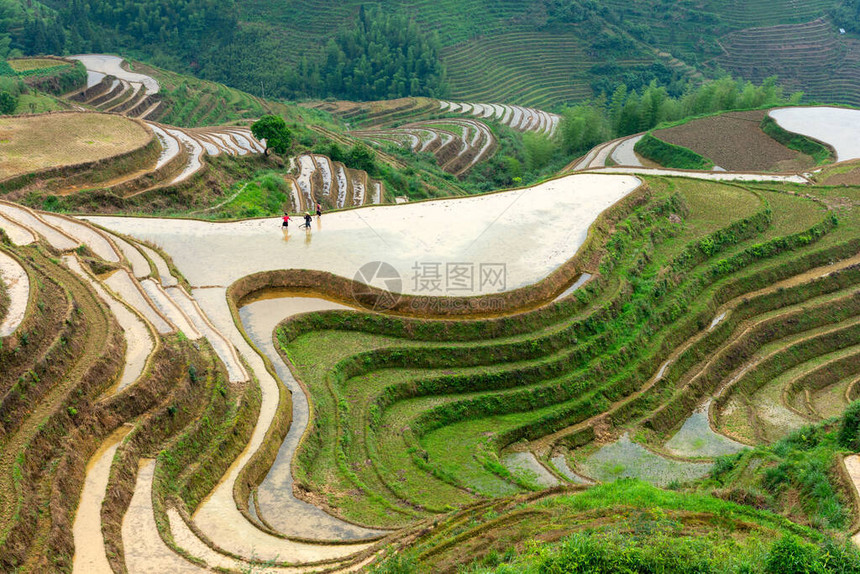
top-left (0, 113), bottom-right (151, 179)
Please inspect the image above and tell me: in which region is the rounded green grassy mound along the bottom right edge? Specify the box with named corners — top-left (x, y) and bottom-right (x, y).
top-left (370, 480), bottom-right (852, 574)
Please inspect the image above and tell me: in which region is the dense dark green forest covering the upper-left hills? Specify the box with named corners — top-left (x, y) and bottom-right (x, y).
top-left (0, 0), bottom-right (446, 100)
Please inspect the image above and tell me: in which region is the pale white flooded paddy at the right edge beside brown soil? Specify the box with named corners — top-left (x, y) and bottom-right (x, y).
top-left (770, 107), bottom-right (860, 161)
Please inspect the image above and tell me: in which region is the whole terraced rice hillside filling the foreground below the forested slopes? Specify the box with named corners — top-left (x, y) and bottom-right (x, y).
top-left (6, 90), bottom-right (860, 574)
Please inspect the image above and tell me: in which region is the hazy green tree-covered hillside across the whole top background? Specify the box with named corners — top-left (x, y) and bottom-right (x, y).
top-left (0, 0), bottom-right (860, 109)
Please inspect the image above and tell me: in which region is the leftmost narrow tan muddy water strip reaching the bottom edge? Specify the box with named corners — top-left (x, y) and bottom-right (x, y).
top-left (72, 426), bottom-right (131, 574)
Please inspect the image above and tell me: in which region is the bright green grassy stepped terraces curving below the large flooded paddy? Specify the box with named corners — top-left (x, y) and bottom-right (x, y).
top-left (268, 180), bottom-right (860, 540)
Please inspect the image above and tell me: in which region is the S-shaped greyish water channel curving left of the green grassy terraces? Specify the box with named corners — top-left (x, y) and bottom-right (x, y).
top-left (239, 297), bottom-right (380, 540)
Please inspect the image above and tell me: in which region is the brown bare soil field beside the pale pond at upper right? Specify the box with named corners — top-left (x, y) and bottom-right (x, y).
top-left (654, 110), bottom-right (814, 172)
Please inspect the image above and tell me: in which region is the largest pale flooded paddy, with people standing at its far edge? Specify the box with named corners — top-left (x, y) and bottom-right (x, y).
top-left (88, 174), bottom-right (640, 296)
